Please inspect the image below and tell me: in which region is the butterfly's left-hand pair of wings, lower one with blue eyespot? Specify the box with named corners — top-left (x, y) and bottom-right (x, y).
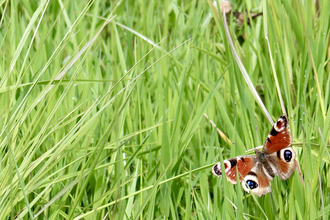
top-left (212, 155), bottom-right (272, 197)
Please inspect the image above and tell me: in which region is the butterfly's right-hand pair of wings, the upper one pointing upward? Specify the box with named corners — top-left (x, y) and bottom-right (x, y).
top-left (263, 115), bottom-right (297, 180)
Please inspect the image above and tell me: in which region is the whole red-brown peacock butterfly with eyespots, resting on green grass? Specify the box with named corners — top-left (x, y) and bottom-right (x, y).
top-left (212, 115), bottom-right (299, 197)
